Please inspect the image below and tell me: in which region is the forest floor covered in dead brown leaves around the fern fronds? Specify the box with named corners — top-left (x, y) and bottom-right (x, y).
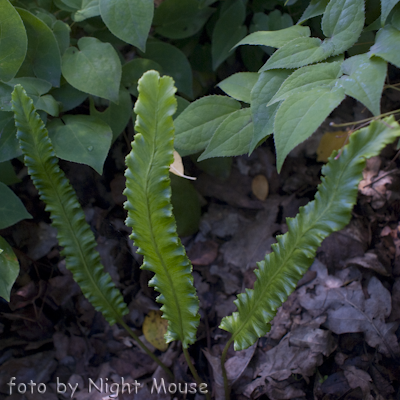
top-left (0, 88), bottom-right (400, 400)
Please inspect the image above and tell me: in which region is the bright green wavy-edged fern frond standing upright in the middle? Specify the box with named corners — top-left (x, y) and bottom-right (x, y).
top-left (124, 71), bottom-right (199, 348)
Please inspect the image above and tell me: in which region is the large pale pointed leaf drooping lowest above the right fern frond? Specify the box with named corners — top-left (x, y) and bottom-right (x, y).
top-left (274, 87), bottom-right (345, 171)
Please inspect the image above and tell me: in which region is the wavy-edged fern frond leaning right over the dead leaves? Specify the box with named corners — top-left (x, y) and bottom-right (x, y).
top-left (220, 117), bottom-right (400, 350)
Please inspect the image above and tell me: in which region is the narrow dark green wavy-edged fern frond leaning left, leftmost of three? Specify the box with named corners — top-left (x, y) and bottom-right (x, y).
top-left (12, 85), bottom-right (128, 324)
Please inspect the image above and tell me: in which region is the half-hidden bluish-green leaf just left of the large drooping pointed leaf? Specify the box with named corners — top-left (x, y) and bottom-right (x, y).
top-left (249, 70), bottom-right (291, 153)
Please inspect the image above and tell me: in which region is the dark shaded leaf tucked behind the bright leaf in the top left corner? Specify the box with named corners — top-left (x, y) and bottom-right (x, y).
top-left (17, 8), bottom-right (61, 86)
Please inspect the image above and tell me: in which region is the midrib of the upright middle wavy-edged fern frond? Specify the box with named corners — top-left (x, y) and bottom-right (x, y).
top-left (146, 93), bottom-right (184, 339)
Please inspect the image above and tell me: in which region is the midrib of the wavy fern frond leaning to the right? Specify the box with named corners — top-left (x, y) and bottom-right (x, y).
top-left (232, 151), bottom-right (353, 340)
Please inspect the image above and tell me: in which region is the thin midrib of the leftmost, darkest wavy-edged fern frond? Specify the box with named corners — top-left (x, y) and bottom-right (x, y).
top-left (24, 104), bottom-right (121, 320)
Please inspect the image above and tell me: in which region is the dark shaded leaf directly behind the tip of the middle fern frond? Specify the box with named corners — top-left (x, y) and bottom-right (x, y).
top-left (143, 41), bottom-right (193, 97)
